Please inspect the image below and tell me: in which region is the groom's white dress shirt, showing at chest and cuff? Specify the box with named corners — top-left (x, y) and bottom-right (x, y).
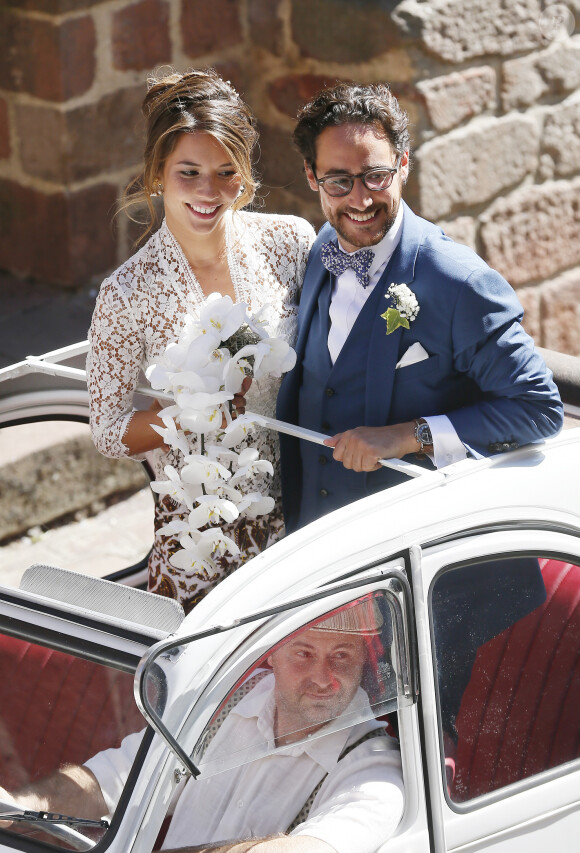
top-left (328, 204), bottom-right (467, 468)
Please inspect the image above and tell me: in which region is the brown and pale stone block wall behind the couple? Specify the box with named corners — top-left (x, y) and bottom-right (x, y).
top-left (0, 0), bottom-right (580, 354)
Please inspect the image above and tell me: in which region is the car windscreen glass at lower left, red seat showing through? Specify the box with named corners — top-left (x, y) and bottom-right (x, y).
top-left (0, 634), bottom-right (145, 850)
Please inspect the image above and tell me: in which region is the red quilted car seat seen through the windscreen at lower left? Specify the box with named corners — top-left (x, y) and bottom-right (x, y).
top-left (0, 636), bottom-right (145, 791)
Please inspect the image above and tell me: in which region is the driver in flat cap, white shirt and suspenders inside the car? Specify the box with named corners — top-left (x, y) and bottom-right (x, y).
top-left (0, 598), bottom-right (404, 853)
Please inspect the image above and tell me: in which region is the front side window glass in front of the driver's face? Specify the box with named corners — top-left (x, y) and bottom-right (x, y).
top-left (192, 593), bottom-right (397, 778)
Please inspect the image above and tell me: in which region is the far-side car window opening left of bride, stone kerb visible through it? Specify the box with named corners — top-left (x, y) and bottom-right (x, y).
top-left (0, 419), bottom-right (154, 586)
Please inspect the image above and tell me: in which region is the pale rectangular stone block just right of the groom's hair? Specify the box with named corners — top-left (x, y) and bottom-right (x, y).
top-left (417, 65), bottom-right (496, 131)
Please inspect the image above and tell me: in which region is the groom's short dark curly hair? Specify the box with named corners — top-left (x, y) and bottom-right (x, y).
top-left (292, 83), bottom-right (411, 168)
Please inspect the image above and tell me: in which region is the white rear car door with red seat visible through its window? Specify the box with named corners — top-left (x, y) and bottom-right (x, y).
top-left (412, 524), bottom-right (580, 853)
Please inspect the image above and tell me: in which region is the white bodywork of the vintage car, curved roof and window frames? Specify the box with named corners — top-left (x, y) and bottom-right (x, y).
top-left (0, 344), bottom-right (580, 853)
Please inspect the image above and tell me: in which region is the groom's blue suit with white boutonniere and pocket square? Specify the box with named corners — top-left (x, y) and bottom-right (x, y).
top-left (278, 202), bottom-right (563, 531)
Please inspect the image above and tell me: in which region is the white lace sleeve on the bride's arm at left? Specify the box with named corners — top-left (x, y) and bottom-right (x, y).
top-left (87, 279), bottom-right (144, 458)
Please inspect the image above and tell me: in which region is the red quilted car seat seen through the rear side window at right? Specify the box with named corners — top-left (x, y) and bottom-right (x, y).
top-left (450, 560), bottom-right (580, 802)
